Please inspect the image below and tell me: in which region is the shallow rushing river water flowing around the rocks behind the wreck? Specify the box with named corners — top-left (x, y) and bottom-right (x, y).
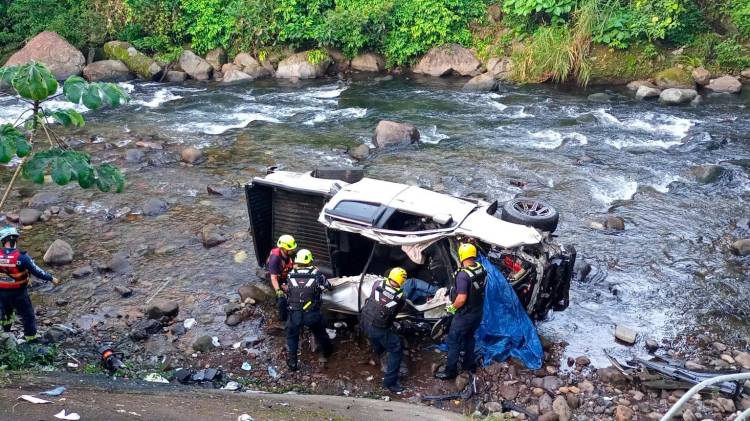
top-left (0, 77), bottom-right (750, 363)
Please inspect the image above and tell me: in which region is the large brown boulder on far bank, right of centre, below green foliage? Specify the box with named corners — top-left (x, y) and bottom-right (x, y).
top-left (413, 44), bottom-right (482, 77)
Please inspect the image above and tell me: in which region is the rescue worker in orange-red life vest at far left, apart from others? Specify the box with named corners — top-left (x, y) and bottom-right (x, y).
top-left (0, 226), bottom-right (60, 342)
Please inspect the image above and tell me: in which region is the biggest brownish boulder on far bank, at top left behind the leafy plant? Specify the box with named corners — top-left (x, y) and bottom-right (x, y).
top-left (5, 31), bottom-right (86, 80)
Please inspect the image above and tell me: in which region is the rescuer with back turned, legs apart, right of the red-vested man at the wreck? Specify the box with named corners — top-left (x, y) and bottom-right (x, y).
top-left (286, 249), bottom-right (333, 371)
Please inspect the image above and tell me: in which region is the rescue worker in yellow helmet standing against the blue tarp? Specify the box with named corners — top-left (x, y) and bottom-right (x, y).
top-left (435, 243), bottom-right (487, 380)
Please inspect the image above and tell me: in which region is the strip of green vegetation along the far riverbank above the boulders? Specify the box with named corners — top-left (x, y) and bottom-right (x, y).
top-left (0, 0), bottom-right (750, 85)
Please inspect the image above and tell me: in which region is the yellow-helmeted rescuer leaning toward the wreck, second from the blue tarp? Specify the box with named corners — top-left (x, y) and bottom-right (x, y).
top-left (361, 267), bottom-right (406, 393)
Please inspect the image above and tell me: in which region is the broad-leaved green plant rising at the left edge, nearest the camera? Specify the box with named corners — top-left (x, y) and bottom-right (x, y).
top-left (0, 61), bottom-right (129, 208)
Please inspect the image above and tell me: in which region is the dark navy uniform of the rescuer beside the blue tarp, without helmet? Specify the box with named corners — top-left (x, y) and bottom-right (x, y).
top-left (445, 263), bottom-right (487, 376)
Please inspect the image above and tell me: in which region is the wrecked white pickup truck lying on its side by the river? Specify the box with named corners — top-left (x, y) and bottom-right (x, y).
top-left (245, 169), bottom-right (576, 320)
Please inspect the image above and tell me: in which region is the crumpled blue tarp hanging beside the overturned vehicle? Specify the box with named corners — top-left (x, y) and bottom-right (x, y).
top-left (476, 256), bottom-right (544, 369)
